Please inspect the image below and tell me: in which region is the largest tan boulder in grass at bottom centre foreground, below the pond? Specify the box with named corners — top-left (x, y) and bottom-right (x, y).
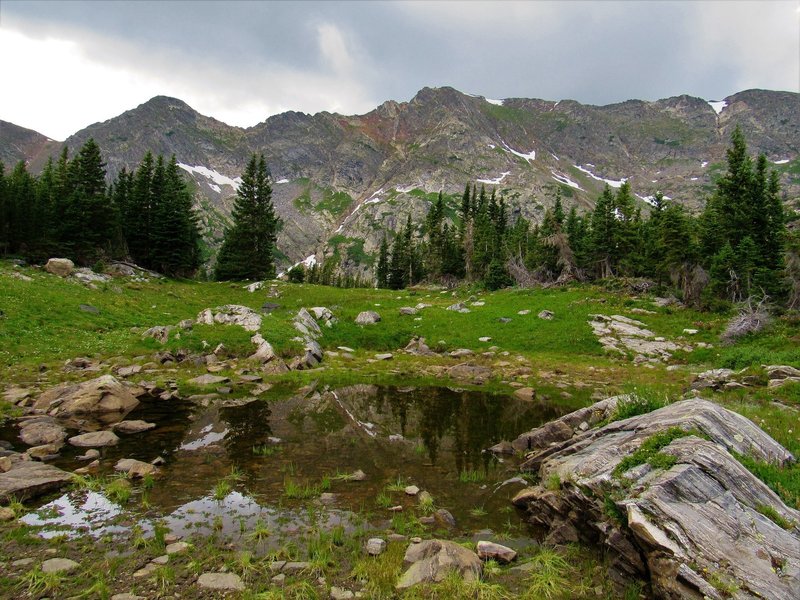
top-left (397, 540), bottom-right (483, 591)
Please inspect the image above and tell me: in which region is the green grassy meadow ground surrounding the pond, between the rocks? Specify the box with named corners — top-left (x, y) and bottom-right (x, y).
top-left (0, 262), bottom-right (800, 598)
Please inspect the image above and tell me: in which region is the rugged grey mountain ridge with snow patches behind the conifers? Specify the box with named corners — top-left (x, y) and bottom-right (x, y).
top-left (0, 87), bottom-right (800, 267)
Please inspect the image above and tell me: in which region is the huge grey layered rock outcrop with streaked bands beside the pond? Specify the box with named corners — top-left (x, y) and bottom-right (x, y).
top-left (514, 399), bottom-right (800, 600)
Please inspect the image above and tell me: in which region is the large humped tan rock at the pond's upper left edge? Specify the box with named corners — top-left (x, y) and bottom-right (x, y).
top-left (34, 375), bottom-right (139, 420)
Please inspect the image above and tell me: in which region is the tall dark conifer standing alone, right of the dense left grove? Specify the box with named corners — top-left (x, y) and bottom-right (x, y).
top-left (216, 154), bottom-right (279, 279)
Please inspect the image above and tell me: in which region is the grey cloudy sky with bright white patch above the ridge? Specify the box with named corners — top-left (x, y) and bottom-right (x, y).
top-left (0, 0), bottom-right (800, 140)
